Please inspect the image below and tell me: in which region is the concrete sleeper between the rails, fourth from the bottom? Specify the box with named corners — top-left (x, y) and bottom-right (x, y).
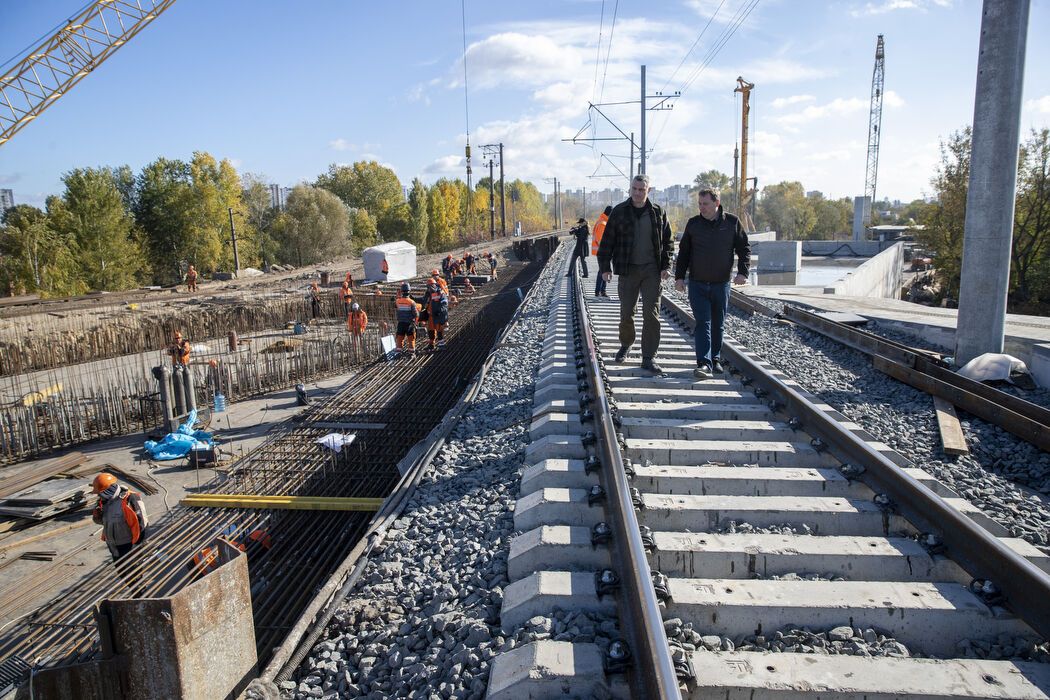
top-left (638, 493), bottom-right (915, 537)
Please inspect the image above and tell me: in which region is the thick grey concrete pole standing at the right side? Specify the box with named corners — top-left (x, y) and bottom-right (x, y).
top-left (956, 0), bottom-right (1029, 365)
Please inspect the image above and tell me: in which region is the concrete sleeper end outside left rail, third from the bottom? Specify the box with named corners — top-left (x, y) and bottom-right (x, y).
top-left (507, 525), bottom-right (611, 581)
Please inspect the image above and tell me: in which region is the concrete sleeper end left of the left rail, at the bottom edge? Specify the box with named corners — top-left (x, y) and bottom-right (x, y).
top-left (486, 639), bottom-right (630, 700)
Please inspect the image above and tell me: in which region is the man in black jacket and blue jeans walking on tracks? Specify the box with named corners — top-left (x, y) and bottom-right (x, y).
top-left (674, 188), bottom-right (751, 379)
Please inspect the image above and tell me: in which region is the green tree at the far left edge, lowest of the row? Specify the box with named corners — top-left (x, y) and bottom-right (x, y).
top-left (0, 205), bottom-right (87, 297)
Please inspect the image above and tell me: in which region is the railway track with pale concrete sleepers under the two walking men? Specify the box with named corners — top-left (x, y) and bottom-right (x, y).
top-left (488, 270), bottom-right (1050, 698)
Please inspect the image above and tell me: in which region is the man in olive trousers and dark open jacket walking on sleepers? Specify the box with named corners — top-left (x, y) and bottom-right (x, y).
top-left (597, 174), bottom-right (671, 374)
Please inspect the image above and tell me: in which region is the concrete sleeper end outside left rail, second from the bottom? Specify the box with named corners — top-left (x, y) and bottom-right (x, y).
top-left (500, 571), bottom-right (616, 634)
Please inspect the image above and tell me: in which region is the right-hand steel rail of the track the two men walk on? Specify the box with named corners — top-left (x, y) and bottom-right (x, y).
top-left (662, 297), bottom-right (1050, 638)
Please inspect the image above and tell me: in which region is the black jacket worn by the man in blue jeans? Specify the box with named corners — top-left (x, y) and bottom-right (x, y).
top-left (674, 207), bottom-right (751, 283)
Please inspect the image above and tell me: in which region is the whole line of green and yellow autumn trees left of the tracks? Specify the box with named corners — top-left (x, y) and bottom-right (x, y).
top-left (0, 152), bottom-right (550, 297)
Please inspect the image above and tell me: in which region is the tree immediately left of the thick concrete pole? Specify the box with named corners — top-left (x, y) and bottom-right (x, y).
top-left (917, 127), bottom-right (972, 299)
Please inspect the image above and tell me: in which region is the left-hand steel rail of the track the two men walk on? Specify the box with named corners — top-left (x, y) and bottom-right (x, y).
top-left (570, 274), bottom-right (681, 699)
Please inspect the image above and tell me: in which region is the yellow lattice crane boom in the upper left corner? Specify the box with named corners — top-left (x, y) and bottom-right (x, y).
top-left (0, 0), bottom-right (175, 146)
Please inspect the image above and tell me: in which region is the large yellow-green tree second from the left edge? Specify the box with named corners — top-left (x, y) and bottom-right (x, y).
top-left (47, 168), bottom-right (146, 291)
